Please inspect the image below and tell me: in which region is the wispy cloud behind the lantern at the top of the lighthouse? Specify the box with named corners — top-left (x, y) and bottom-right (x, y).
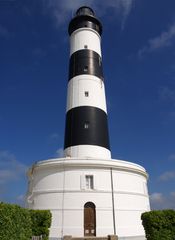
top-left (43, 0), bottom-right (135, 28)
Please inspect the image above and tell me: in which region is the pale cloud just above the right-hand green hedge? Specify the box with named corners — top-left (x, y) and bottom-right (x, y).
top-left (150, 192), bottom-right (175, 209)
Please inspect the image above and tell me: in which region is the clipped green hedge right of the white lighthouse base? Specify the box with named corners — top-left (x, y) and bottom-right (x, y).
top-left (141, 210), bottom-right (175, 240)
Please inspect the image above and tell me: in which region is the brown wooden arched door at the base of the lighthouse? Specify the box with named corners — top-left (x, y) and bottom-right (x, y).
top-left (84, 202), bottom-right (96, 236)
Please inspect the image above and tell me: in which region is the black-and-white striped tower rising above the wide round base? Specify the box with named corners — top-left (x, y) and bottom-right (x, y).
top-left (64, 7), bottom-right (111, 159)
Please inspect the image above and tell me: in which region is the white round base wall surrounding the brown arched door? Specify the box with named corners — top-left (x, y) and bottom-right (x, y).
top-left (27, 158), bottom-right (150, 238)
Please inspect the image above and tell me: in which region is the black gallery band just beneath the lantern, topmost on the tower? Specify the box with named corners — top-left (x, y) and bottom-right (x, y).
top-left (68, 15), bottom-right (102, 35)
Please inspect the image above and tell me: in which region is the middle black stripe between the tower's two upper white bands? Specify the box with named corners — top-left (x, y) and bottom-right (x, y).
top-left (69, 49), bottom-right (103, 80)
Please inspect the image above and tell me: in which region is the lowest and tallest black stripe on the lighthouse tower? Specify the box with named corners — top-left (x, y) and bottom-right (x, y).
top-left (64, 106), bottom-right (110, 149)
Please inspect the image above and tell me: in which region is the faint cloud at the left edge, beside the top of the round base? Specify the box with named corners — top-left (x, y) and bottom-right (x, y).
top-left (0, 151), bottom-right (27, 185)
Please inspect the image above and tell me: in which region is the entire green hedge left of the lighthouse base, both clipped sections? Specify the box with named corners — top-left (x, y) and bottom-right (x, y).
top-left (0, 203), bottom-right (51, 240)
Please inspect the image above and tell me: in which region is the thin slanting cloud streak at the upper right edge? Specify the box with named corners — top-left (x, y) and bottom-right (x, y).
top-left (138, 23), bottom-right (175, 57)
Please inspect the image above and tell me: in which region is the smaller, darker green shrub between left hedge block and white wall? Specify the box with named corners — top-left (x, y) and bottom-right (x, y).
top-left (29, 210), bottom-right (51, 240)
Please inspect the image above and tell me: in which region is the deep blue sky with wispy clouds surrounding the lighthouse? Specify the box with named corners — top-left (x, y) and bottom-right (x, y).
top-left (0, 0), bottom-right (175, 209)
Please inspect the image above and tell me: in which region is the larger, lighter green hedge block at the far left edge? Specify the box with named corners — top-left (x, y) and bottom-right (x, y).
top-left (0, 203), bottom-right (32, 240)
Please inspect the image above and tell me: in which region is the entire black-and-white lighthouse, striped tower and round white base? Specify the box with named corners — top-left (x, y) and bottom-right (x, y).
top-left (26, 6), bottom-right (150, 240)
